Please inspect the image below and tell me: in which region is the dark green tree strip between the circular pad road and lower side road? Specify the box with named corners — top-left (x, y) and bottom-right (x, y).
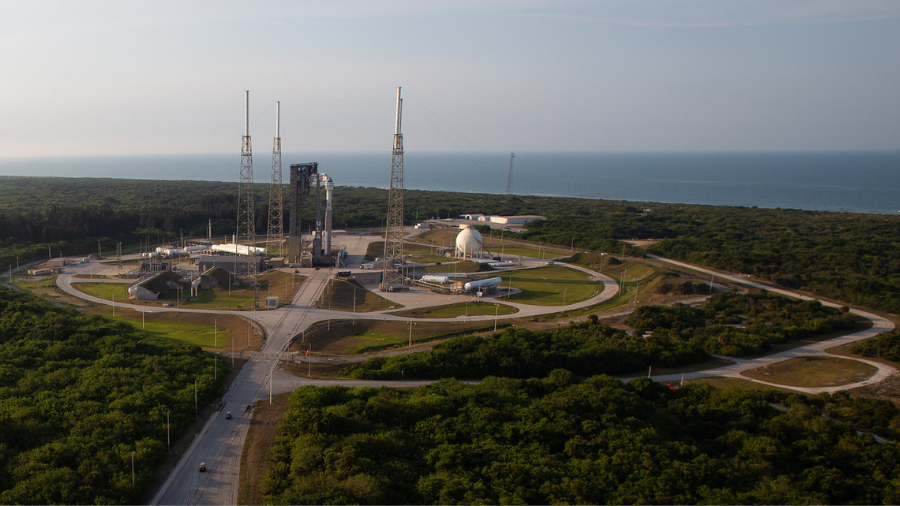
top-left (342, 293), bottom-right (856, 379)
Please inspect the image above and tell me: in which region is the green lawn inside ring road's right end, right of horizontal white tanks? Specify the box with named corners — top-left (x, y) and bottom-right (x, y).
top-left (500, 265), bottom-right (603, 306)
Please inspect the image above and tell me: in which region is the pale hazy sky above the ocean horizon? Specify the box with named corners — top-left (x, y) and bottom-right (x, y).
top-left (0, 0), bottom-right (900, 157)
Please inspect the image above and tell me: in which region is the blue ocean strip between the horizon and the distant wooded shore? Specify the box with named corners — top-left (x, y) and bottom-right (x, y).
top-left (0, 151), bottom-right (900, 214)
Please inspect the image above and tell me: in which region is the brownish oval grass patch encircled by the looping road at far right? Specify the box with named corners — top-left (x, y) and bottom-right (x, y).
top-left (741, 357), bottom-right (878, 388)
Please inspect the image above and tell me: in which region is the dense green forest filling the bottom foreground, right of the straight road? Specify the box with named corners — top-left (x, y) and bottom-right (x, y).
top-left (261, 370), bottom-right (900, 504)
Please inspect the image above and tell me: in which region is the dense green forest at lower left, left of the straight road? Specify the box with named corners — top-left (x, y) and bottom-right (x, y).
top-left (0, 289), bottom-right (228, 504)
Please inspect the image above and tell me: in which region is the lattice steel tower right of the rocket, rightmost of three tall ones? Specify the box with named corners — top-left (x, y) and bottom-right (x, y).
top-left (381, 87), bottom-right (403, 292)
